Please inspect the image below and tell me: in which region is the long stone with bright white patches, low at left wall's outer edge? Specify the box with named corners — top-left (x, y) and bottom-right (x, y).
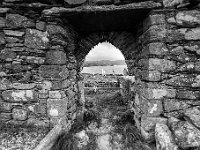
top-left (2, 90), bottom-right (38, 102)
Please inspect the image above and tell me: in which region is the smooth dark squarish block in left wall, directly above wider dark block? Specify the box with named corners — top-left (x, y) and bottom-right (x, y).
top-left (45, 50), bottom-right (67, 65)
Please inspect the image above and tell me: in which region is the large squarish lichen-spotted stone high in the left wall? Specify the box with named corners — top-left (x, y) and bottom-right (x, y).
top-left (25, 29), bottom-right (49, 49)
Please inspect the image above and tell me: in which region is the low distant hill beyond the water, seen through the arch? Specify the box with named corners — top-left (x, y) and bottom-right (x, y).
top-left (83, 60), bottom-right (126, 67)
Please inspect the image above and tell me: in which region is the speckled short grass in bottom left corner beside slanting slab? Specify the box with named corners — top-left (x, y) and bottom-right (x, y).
top-left (0, 124), bottom-right (49, 150)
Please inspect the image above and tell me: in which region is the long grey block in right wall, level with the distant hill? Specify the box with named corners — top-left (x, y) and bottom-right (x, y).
top-left (138, 58), bottom-right (176, 72)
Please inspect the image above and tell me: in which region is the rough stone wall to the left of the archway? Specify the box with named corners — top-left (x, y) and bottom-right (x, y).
top-left (0, 4), bottom-right (78, 127)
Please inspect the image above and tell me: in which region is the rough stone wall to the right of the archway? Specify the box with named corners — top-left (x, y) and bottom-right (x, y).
top-left (134, 1), bottom-right (200, 149)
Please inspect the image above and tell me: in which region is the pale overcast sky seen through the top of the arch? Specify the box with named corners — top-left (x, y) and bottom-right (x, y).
top-left (86, 42), bottom-right (124, 61)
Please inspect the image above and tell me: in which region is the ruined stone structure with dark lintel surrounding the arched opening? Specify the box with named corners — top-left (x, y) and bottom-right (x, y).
top-left (0, 0), bottom-right (200, 149)
